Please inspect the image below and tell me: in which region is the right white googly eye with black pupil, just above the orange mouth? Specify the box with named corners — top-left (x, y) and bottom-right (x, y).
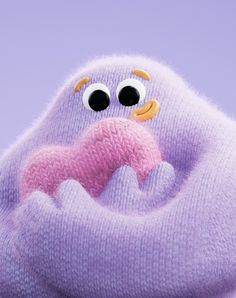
top-left (116, 79), bottom-right (146, 106)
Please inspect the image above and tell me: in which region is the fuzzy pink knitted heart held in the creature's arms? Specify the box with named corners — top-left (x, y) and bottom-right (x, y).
top-left (20, 118), bottom-right (161, 198)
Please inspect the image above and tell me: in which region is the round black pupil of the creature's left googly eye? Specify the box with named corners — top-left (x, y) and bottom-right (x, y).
top-left (88, 90), bottom-right (110, 112)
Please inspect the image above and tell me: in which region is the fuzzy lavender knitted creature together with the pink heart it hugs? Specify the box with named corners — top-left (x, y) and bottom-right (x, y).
top-left (0, 56), bottom-right (236, 298)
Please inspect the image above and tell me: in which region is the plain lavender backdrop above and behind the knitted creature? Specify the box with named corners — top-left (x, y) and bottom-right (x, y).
top-left (0, 0), bottom-right (236, 156)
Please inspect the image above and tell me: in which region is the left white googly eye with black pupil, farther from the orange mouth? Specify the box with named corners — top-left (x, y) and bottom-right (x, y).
top-left (83, 83), bottom-right (110, 112)
